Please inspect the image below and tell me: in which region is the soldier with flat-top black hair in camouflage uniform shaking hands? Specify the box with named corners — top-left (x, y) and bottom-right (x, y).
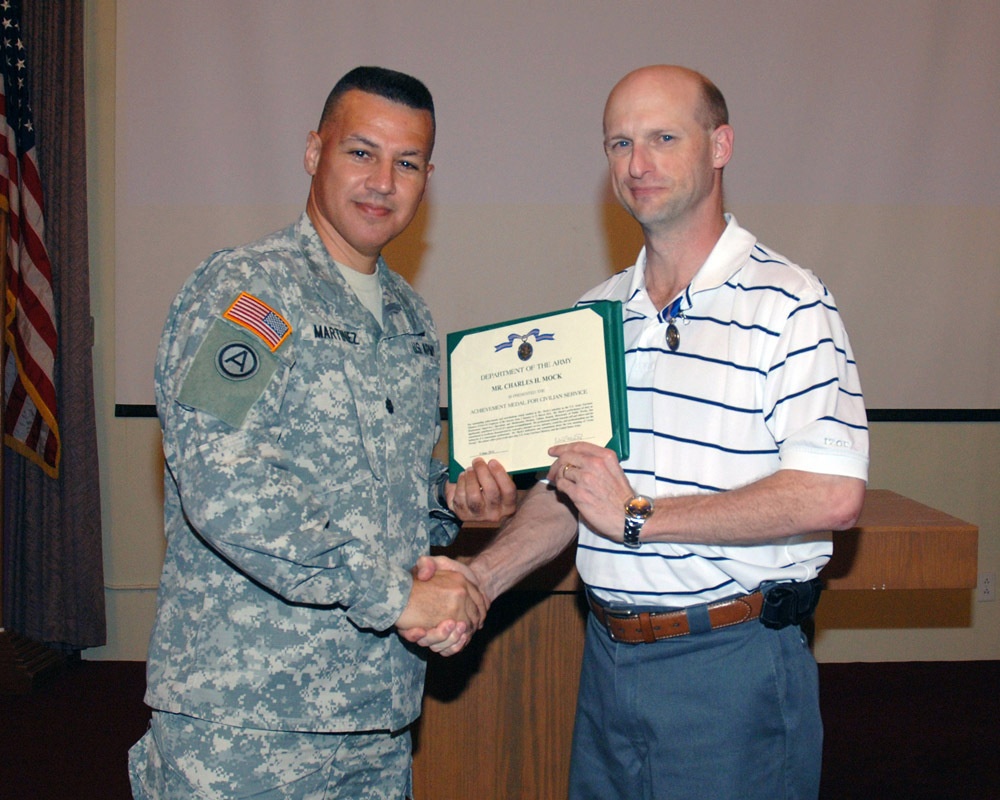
top-left (130, 67), bottom-right (513, 800)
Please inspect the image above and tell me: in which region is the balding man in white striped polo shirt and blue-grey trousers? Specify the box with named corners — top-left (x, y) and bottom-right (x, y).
top-left (406, 66), bottom-right (868, 800)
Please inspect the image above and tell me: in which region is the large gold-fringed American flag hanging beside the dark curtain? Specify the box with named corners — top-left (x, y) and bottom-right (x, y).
top-left (0, 0), bottom-right (60, 478)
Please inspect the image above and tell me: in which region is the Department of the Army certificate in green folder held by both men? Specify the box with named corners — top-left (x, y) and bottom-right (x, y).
top-left (447, 300), bottom-right (628, 481)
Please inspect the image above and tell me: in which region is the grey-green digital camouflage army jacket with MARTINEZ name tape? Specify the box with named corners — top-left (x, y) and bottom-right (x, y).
top-left (140, 215), bottom-right (457, 732)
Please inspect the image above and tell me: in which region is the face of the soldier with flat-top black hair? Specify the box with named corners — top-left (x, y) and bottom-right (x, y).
top-left (305, 90), bottom-right (434, 271)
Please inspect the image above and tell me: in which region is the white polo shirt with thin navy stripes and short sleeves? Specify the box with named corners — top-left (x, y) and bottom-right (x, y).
top-left (577, 215), bottom-right (868, 606)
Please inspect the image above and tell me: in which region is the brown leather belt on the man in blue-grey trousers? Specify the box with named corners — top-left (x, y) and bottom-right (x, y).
top-left (587, 592), bottom-right (764, 644)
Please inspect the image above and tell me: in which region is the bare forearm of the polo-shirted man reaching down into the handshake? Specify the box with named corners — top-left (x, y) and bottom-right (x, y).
top-left (469, 483), bottom-right (577, 602)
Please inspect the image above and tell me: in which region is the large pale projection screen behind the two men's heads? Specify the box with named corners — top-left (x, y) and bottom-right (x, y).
top-left (115, 0), bottom-right (1000, 411)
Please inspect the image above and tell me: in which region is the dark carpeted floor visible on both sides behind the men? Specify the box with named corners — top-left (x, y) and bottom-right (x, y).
top-left (0, 661), bottom-right (1000, 800)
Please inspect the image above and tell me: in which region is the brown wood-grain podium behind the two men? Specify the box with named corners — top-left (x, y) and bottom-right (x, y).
top-left (414, 489), bottom-right (979, 800)
